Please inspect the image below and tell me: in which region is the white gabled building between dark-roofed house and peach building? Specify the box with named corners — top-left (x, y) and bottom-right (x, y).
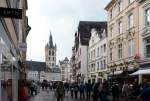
top-left (88, 22), bottom-right (107, 82)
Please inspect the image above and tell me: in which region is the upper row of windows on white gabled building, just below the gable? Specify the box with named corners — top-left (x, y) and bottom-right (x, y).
top-left (89, 44), bottom-right (106, 59)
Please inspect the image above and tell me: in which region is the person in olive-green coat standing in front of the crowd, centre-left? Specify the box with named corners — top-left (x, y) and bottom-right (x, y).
top-left (56, 82), bottom-right (65, 101)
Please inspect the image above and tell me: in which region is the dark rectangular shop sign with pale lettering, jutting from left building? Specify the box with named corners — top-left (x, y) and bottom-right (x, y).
top-left (0, 7), bottom-right (22, 19)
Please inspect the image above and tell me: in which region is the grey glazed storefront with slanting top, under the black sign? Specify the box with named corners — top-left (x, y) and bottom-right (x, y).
top-left (0, 21), bottom-right (19, 101)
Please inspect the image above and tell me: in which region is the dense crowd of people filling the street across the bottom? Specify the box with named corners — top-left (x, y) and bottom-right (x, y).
top-left (19, 79), bottom-right (150, 101)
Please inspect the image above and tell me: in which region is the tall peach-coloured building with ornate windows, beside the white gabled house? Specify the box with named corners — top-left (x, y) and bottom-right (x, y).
top-left (105, 0), bottom-right (140, 82)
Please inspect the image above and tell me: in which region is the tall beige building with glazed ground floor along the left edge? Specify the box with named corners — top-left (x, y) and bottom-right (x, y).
top-left (0, 0), bottom-right (30, 101)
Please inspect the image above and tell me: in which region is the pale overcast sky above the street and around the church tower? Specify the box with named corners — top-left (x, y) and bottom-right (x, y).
top-left (27, 0), bottom-right (110, 61)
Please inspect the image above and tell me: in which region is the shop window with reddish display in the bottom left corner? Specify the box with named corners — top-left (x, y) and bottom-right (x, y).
top-left (0, 55), bottom-right (13, 101)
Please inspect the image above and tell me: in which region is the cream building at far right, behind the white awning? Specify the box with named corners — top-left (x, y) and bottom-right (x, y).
top-left (137, 0), bottom-right (150, 83)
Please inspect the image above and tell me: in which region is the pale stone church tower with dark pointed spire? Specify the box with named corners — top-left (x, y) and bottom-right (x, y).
top-left (45, 32), bottom-right (57, 68)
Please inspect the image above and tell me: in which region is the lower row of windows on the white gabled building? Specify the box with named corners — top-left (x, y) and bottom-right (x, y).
top-left (89, 60), bottom-right (106, 72)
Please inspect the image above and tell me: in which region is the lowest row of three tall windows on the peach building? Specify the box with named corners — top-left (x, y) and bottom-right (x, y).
top-left (109, 39), bottom-right (135, 61)
